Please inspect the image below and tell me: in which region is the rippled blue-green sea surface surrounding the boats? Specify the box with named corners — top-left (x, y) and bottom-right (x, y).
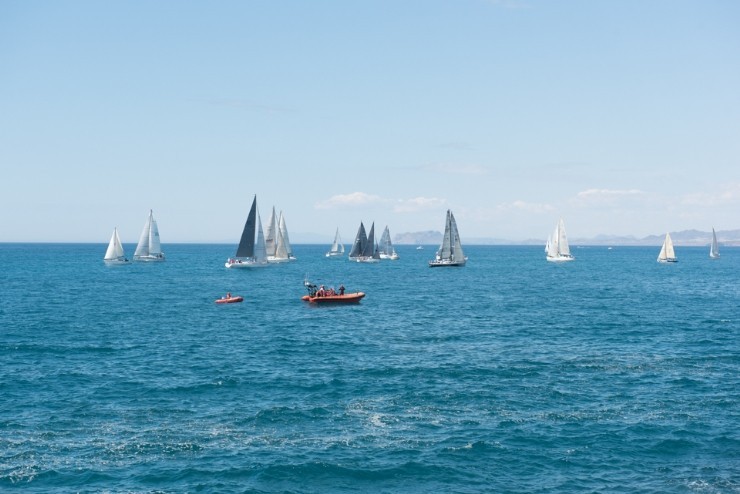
top-left (0, 244), bottom-right (740, 493)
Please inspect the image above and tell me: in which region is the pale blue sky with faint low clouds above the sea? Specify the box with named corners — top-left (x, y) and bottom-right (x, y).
top-left (0, 0), bottom-right (740, 244)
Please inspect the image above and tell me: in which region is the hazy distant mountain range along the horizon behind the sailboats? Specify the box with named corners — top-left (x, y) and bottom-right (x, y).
top-left (393, 230), bottom-right (740, 247)
